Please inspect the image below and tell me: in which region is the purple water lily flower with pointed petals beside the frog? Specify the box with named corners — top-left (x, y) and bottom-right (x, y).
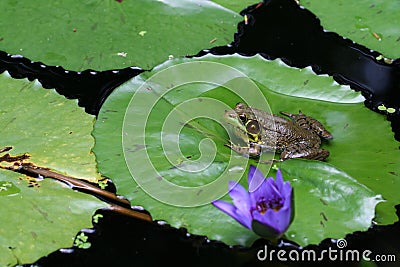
top-left (212, 165), bottom-right (294, 239)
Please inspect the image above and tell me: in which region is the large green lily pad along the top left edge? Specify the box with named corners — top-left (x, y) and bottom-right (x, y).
top-left (0, 0), bottom-right (242, 71)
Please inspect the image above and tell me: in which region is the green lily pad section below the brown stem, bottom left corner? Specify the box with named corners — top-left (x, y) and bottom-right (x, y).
top-left (0, 170), bottom-right (104, 266)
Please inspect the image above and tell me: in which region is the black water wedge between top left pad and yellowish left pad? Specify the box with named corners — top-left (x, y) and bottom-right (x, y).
top-left (0, 51), bottom-right (143, 115)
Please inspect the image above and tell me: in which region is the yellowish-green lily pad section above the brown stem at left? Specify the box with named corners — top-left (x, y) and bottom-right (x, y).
top-left (0, 74), bottom-right (100, 182)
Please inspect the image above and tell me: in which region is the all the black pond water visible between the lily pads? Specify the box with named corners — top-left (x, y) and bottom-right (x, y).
top-left (0, 0), bottom-right (400, 266)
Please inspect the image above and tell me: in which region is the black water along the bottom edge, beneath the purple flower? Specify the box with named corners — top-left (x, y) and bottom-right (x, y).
top-left (26, 209), bottom-right (400, 267)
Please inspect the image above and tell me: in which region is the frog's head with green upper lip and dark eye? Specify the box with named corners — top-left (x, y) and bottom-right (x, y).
top-left (224, 103), bottom-right (261, 143)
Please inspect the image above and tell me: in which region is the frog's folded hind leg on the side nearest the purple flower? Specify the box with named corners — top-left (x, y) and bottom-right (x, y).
top-left (281, 145), bottom-right (329, 160)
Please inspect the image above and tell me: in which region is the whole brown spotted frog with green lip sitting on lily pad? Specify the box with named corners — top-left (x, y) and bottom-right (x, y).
top-left (224, 102), bottom-right (333, 161)
